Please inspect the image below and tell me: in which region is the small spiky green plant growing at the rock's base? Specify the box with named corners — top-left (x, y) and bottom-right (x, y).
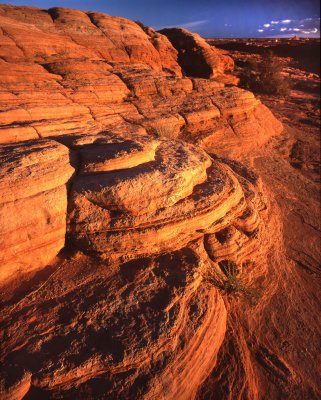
top-left (207, 260), bottom-right (261, 301)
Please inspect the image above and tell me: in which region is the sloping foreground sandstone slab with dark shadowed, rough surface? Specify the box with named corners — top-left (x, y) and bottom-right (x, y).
top-left (1, 244), bottom-right (226, 400)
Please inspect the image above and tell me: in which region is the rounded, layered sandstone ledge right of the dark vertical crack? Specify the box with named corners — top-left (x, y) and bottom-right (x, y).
top-left (68, 135), bottom-right (258, 257)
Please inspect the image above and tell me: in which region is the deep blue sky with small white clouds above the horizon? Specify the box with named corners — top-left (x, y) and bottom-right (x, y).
top-left (5, 0), bottom-right (320, 37)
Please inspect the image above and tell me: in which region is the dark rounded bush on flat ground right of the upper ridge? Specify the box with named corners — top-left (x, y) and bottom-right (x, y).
top-left (241, 50), bottom-right (291, 97)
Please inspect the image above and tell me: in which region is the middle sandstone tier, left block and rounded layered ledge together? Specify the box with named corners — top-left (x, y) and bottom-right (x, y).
top-left (0, 130), bottom-right (264, 290)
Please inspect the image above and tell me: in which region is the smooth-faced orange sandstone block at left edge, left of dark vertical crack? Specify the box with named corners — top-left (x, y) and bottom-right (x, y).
top-left (0, 140), bottom-right (74, 283)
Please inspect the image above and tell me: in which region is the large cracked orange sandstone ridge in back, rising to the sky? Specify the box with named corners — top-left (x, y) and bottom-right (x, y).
top-left (0, 5), bottom-right (282, 157)
